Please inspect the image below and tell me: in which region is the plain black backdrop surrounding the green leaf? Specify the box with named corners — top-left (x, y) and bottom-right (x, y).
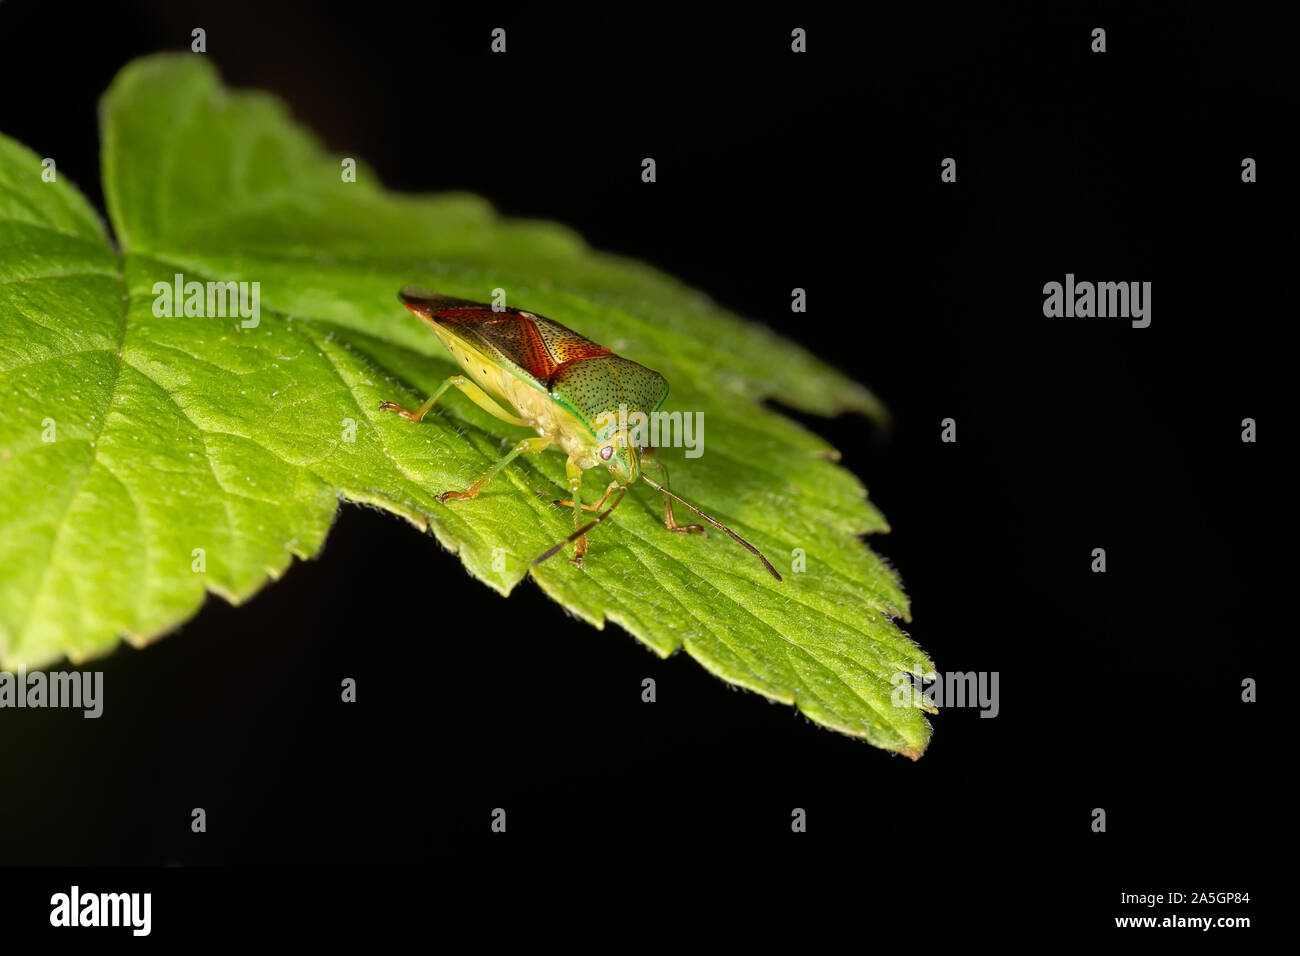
top-left (0, 1), bottom-right (1279, 939)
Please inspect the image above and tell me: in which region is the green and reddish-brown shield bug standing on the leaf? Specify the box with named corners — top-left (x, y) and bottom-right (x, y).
top-left (380, 286), bottom-right (781, 580)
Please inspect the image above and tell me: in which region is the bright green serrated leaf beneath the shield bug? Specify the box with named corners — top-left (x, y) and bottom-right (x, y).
top-left (0, 57), bottom-right (933, 757)
